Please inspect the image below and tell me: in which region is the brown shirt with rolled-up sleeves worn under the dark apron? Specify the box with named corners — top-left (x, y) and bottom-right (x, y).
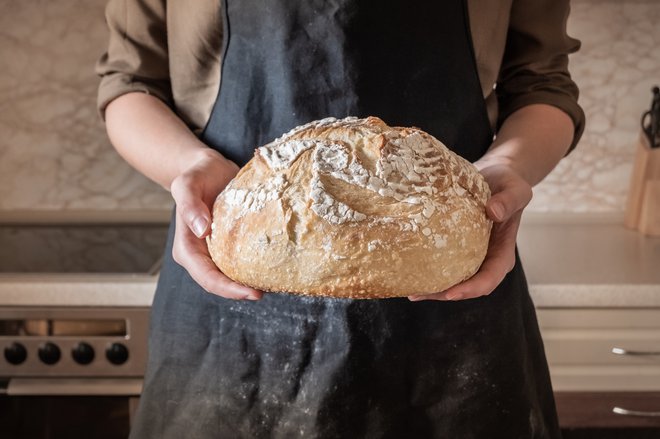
top-left (96, 0), bottom-right (584, 146)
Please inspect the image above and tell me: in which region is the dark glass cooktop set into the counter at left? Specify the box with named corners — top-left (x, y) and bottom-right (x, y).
top-left (0, 224), bottom-right (167, 274)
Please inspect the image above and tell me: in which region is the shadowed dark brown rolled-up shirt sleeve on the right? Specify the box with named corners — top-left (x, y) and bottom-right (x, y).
top-left (496, 0), bottom-right (585, 150)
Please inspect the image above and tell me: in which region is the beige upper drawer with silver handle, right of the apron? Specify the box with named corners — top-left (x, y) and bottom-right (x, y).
top-left (541, 328), bottom-right (660, 367)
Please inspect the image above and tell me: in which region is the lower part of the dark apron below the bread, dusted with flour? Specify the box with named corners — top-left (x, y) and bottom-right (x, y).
top-left (131, 230), bottom-right (560, 439)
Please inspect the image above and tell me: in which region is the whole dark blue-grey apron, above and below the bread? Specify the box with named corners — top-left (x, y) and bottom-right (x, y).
top-left (131, 0), bottom-right (559, 439)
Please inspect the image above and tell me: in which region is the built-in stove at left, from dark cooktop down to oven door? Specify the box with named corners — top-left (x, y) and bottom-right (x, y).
top-left (0, 224), bottom-right (167, 439)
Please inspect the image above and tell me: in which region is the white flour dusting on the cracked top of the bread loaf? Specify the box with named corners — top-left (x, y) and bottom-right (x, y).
top-left (225, 117), bottom-right (489, 247)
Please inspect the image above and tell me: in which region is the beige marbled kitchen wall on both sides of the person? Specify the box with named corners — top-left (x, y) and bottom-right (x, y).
top-left (0, 0), bottom-right (660, 219)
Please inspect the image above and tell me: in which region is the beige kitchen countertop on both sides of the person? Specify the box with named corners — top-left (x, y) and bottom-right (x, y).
top-left (0, 215), bottom-right (660, 308)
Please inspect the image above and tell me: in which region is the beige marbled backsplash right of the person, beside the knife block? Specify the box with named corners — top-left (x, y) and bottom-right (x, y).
top-left (528, 0), bottom-right (660, 212)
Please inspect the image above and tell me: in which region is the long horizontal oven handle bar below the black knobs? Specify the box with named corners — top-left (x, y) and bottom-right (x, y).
top-left (0, 378), bottom-right (143, 396)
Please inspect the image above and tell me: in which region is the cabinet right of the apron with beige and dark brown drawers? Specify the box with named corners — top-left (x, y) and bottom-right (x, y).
top-left (537, 308), bottom-right (660, 427)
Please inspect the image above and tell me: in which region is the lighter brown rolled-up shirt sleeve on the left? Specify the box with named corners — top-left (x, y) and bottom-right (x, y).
top-left (96, 0), bottom-right (172, 118)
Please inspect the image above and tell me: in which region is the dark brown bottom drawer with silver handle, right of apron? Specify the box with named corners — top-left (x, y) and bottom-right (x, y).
top-left (555, 392), bottom-right (660, 428)
